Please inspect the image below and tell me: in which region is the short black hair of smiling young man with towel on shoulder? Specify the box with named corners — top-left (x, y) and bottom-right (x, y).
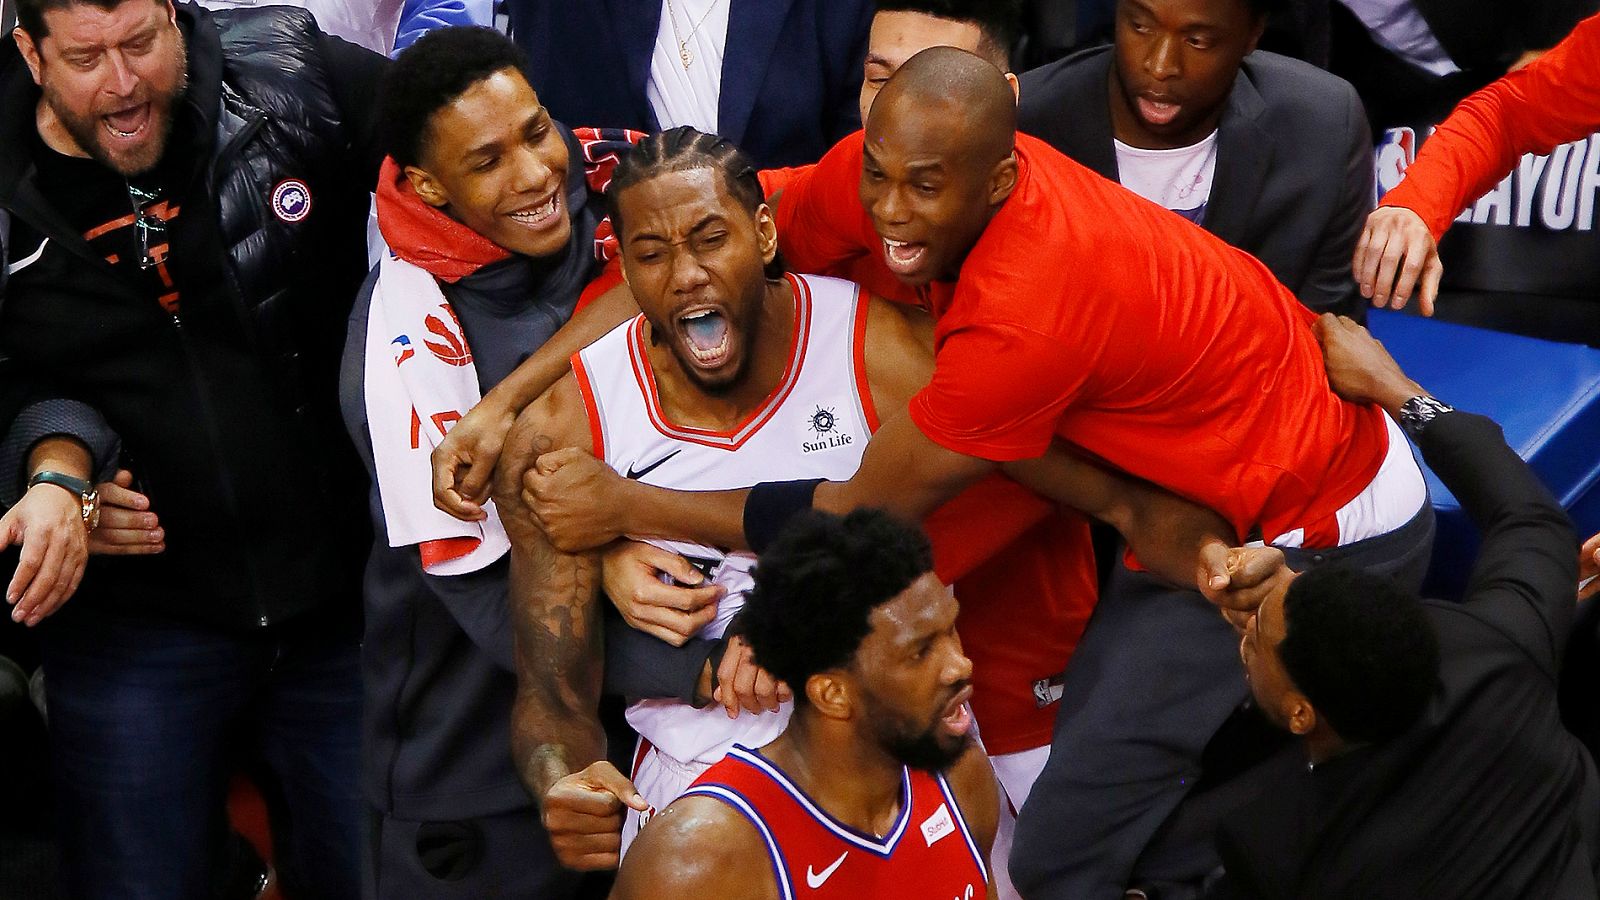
top-left (378, 26), bottom-right (528, 167)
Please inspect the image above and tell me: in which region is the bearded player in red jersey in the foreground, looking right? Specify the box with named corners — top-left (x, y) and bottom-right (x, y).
top-left (611, 509), bottom-right (998, 900)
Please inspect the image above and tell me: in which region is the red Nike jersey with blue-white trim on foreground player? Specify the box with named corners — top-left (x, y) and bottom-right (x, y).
top-left (683, 746), bottom-right (989, 900)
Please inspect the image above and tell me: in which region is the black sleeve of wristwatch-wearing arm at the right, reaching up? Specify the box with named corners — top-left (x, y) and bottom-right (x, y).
top-left (1418, 412), bottom-right (1578, 677)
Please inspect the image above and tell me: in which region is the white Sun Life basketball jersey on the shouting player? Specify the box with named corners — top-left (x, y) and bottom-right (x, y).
top-left (573, 275), bottom-right (878, 764)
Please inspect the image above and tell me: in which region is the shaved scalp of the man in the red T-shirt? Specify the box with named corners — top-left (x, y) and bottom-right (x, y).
top-left (867, 46), bottom-right (1016, 165)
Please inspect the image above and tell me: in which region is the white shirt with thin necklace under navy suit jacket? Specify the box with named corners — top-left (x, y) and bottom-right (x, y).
top-left (645, 0), bottom-right (734, 135)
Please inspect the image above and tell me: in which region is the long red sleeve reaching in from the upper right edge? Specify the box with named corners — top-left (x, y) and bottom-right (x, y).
top-left (1379, 16), bottom-right (1600, 239)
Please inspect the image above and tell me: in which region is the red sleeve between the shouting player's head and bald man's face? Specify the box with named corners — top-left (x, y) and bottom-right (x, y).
top-left (778, 131), bottom-right (875, 272)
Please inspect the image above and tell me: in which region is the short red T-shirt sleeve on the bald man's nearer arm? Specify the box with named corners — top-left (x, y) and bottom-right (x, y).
top-left (910, 317), bottom-right (1088, 463)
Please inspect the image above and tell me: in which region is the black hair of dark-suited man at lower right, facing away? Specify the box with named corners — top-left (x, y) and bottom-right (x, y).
top-left (1278, 565), bottom-right (1438, 741)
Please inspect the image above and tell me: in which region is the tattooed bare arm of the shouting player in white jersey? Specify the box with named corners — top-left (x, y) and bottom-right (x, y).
top-left (494, 373), bottom-right (605, 797)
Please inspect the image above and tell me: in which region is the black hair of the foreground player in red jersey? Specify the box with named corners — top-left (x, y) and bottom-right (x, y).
top-left (739, 509), bottom-right (933, 703)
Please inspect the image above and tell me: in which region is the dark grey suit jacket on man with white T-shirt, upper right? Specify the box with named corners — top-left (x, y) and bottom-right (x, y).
top-left (1018, 48), bottom-right (1373, 320)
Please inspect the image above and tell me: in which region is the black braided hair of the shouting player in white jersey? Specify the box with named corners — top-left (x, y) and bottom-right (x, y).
top-left (605, 125), bottom-right (784, 279)
